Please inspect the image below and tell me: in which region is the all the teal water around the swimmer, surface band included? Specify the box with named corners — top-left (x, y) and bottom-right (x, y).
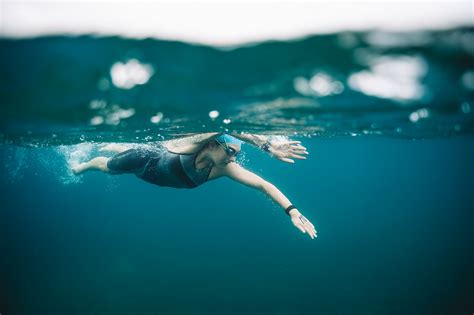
top-left (0, 29), bottom-right (474, 315)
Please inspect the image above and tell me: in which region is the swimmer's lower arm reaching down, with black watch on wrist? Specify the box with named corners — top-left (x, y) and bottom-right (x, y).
top-left (223, 162), bottom-right (316, 239)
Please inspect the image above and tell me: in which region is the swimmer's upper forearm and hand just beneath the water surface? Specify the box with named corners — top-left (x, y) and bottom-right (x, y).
top-left (231, 133), bottom-right (309, 163)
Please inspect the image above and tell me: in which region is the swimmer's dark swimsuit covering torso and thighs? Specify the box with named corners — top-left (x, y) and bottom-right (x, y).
top-left (107, 144), bottom-right (212, 188)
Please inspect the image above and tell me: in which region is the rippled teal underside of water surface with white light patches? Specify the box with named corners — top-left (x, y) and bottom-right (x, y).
top-left (0, 27), bottom-right (474, 146)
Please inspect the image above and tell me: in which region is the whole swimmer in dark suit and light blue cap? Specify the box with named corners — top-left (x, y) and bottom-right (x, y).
top-left (72, 132), bottom-right (316, 239)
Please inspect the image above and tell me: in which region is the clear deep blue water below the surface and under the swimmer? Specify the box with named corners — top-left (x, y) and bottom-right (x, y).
top-left (0, 137), bottom-right (474, 314)
